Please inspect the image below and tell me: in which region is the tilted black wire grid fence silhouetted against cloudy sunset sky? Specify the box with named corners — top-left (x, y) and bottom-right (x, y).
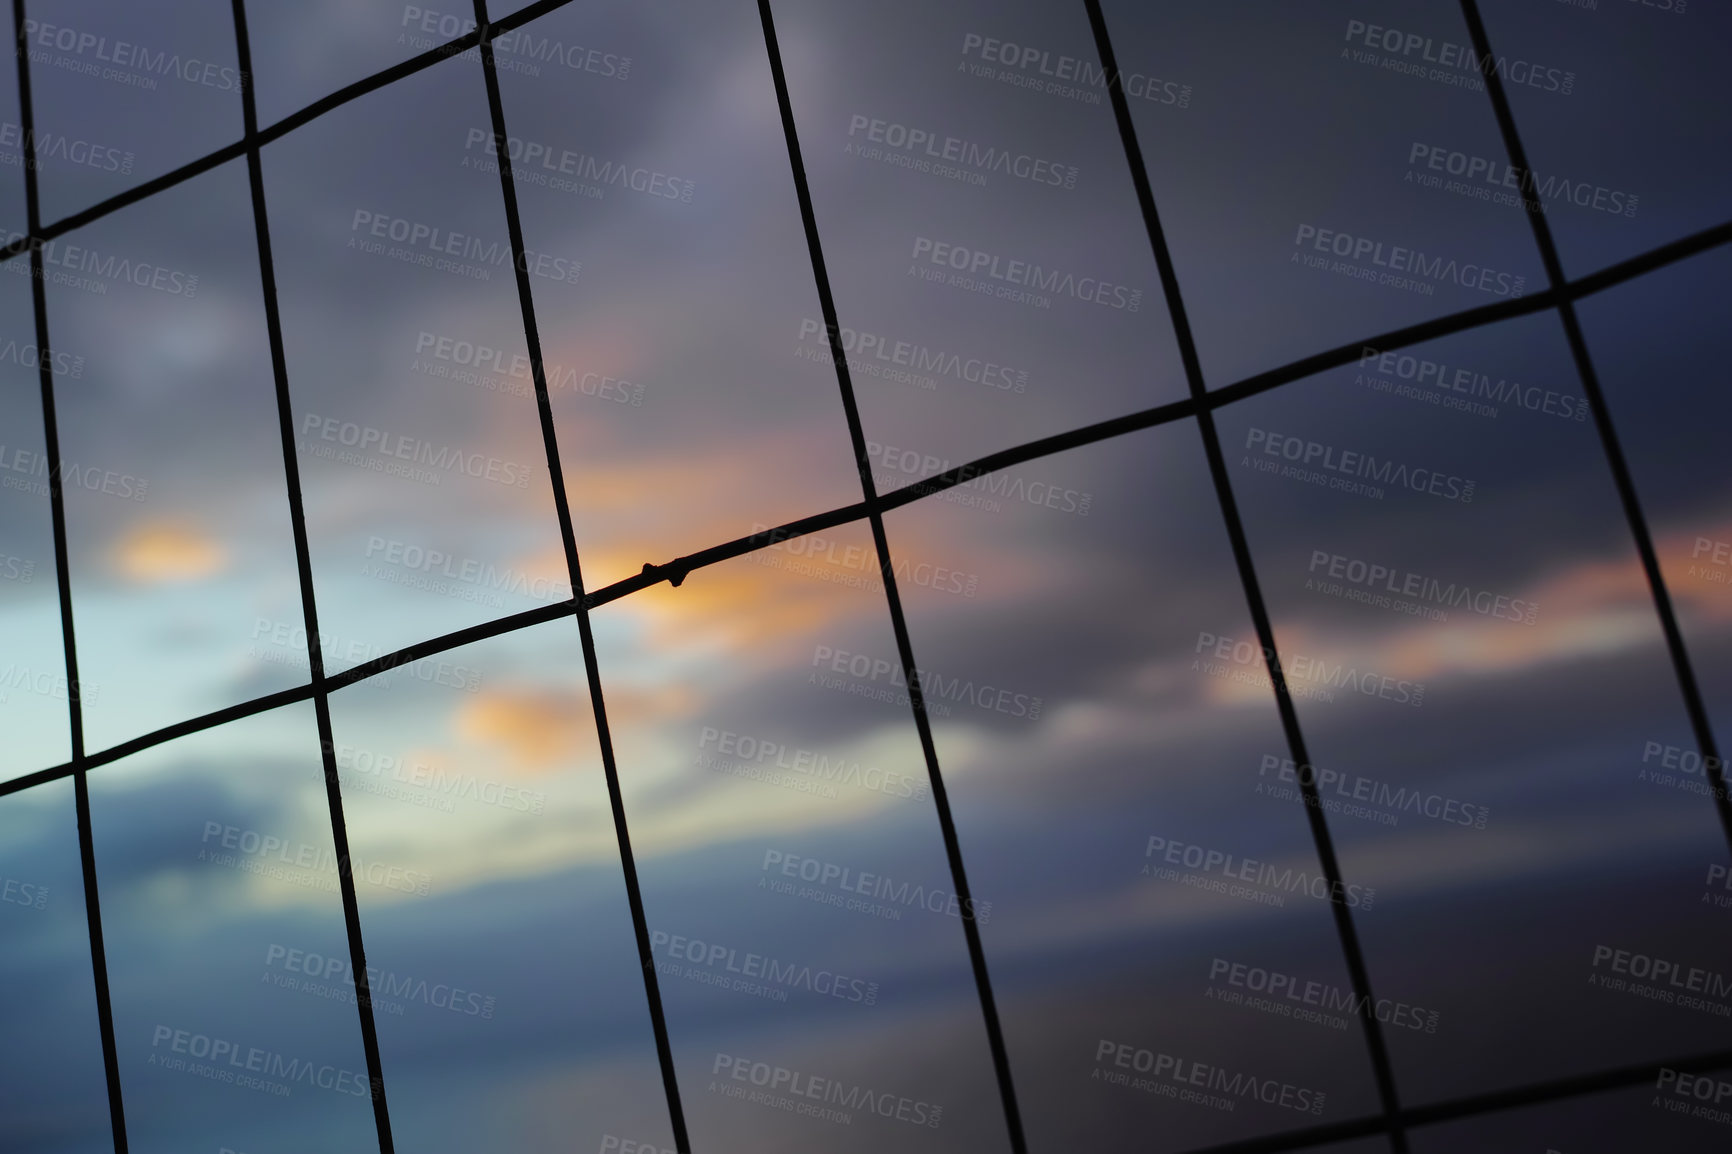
top-left (0, 0), bottom-right (1732, 1154)
